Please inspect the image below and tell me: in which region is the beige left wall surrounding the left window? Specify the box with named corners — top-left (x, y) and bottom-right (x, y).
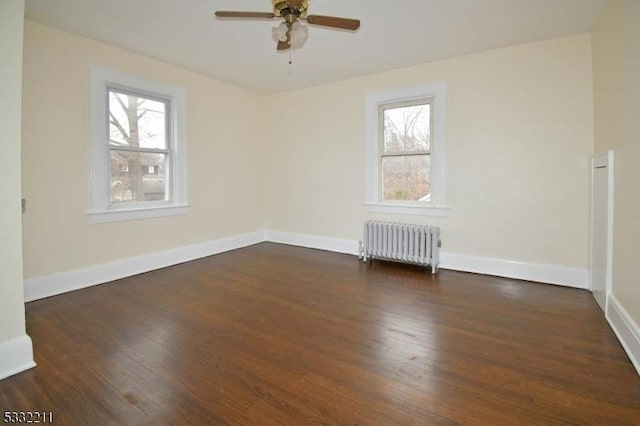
top-left (21, 21), bottom-right (265, 278)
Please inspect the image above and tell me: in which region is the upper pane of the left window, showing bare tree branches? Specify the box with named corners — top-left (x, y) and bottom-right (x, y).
top-left (109, 90), bottom-right (167, 149)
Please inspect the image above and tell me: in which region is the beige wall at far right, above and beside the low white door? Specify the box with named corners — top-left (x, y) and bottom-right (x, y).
top-left (593, 0), bottom-right (640, 324)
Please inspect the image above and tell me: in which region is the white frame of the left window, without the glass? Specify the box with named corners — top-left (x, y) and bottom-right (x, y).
top-left (89, 65), bottom-right (188, 223)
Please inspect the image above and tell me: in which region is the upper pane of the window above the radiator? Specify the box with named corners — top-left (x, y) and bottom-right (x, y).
top-left (383, 104), bottom-right (431, 154)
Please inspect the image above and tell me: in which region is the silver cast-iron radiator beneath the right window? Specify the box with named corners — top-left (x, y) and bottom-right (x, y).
top-left (359, 221), bottom-right (441, 274)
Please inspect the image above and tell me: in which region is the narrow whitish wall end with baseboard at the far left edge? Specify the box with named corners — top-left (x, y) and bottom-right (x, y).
top-left (0, 0), bottom-right (33, 379)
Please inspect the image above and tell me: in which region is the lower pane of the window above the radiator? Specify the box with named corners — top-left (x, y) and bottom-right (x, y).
top-left (382, 155), bottom-right (431, 201)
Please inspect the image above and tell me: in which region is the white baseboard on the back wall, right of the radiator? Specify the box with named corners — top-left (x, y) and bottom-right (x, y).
top-left (440, 252), bottom-right (589, 290)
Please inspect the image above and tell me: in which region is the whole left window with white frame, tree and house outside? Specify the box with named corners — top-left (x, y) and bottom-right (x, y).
top-left (89, 66), bottom-right (187, 223)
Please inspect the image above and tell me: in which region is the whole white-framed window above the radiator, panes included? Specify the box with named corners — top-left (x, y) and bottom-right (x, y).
top-left (366, 83), bottom-right (447, 216)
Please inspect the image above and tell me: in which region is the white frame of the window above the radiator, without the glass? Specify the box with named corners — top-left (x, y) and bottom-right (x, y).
top-left (365, 82), bottom-right (449, 216)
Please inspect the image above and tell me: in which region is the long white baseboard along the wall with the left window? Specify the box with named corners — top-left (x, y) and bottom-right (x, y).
top-left (24, 231), bottom-right (265, 302)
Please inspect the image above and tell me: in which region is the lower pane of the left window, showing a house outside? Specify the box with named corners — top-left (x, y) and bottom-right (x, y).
top-left (111, 150), bottom-right (168, 203)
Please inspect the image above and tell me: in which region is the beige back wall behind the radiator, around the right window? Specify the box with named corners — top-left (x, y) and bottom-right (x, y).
top-left (268, 34), bottom-right (593, 269)
